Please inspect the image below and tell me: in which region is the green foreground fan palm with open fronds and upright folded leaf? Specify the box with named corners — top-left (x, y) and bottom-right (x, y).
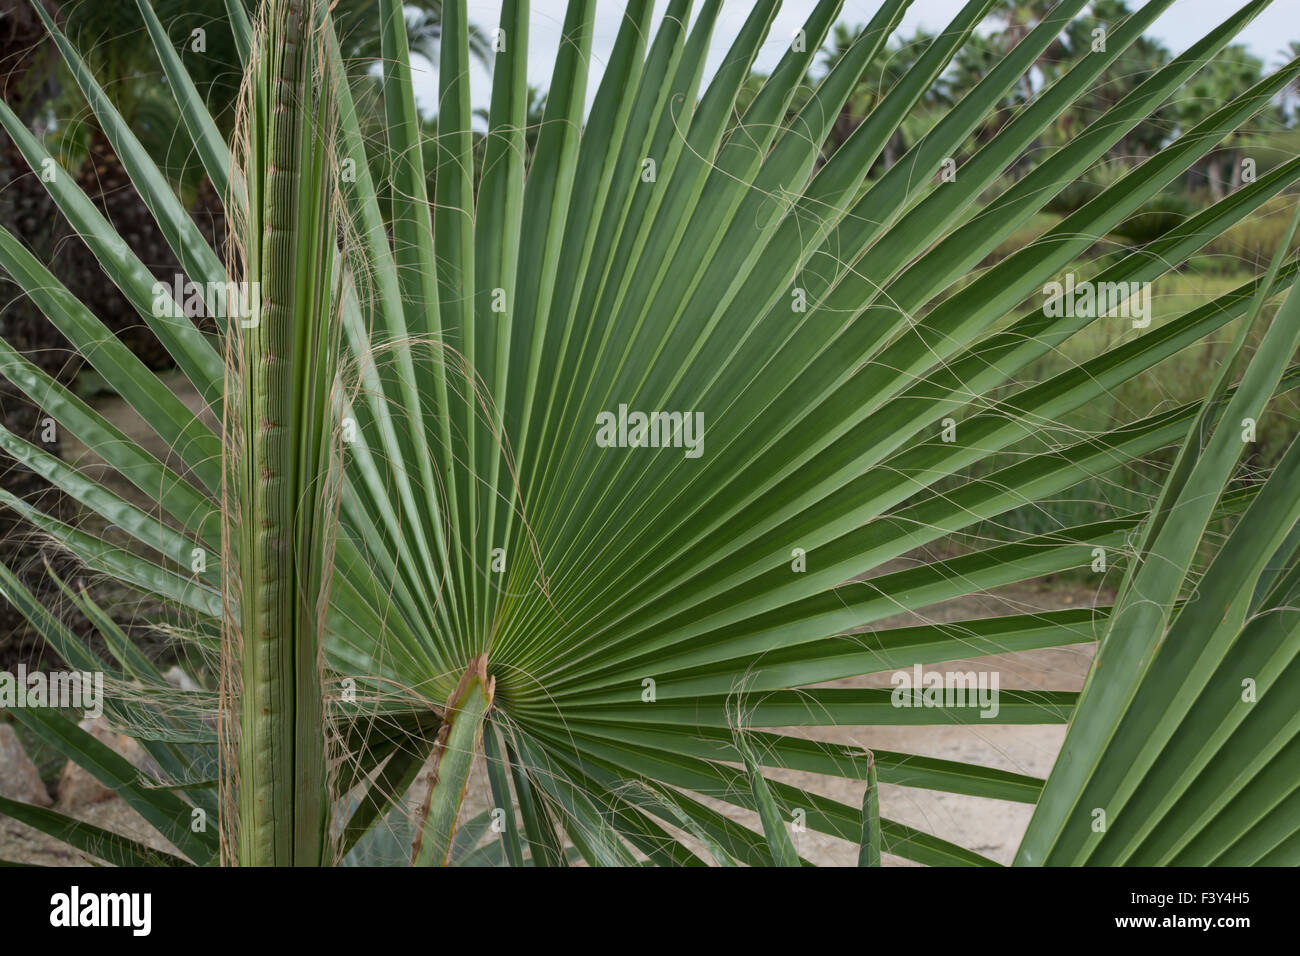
top-left (0, 0), bottom-right (1300, 865)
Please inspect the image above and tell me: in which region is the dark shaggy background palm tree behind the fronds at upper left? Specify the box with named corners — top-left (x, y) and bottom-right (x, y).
top-left (0, 0), bottom-right (490, 662)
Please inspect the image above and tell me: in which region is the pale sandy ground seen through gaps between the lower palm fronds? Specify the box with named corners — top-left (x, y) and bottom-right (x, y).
top-left (0, 377), bottom-right (1105, 866)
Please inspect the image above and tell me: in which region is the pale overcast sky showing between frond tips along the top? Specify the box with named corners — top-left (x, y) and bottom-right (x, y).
top-left (416, 0), bottom-right (1300, 113)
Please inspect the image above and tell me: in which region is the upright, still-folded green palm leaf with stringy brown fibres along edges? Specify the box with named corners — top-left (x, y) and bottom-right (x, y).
top-left (228, 0), bottom-right (338, 866)
